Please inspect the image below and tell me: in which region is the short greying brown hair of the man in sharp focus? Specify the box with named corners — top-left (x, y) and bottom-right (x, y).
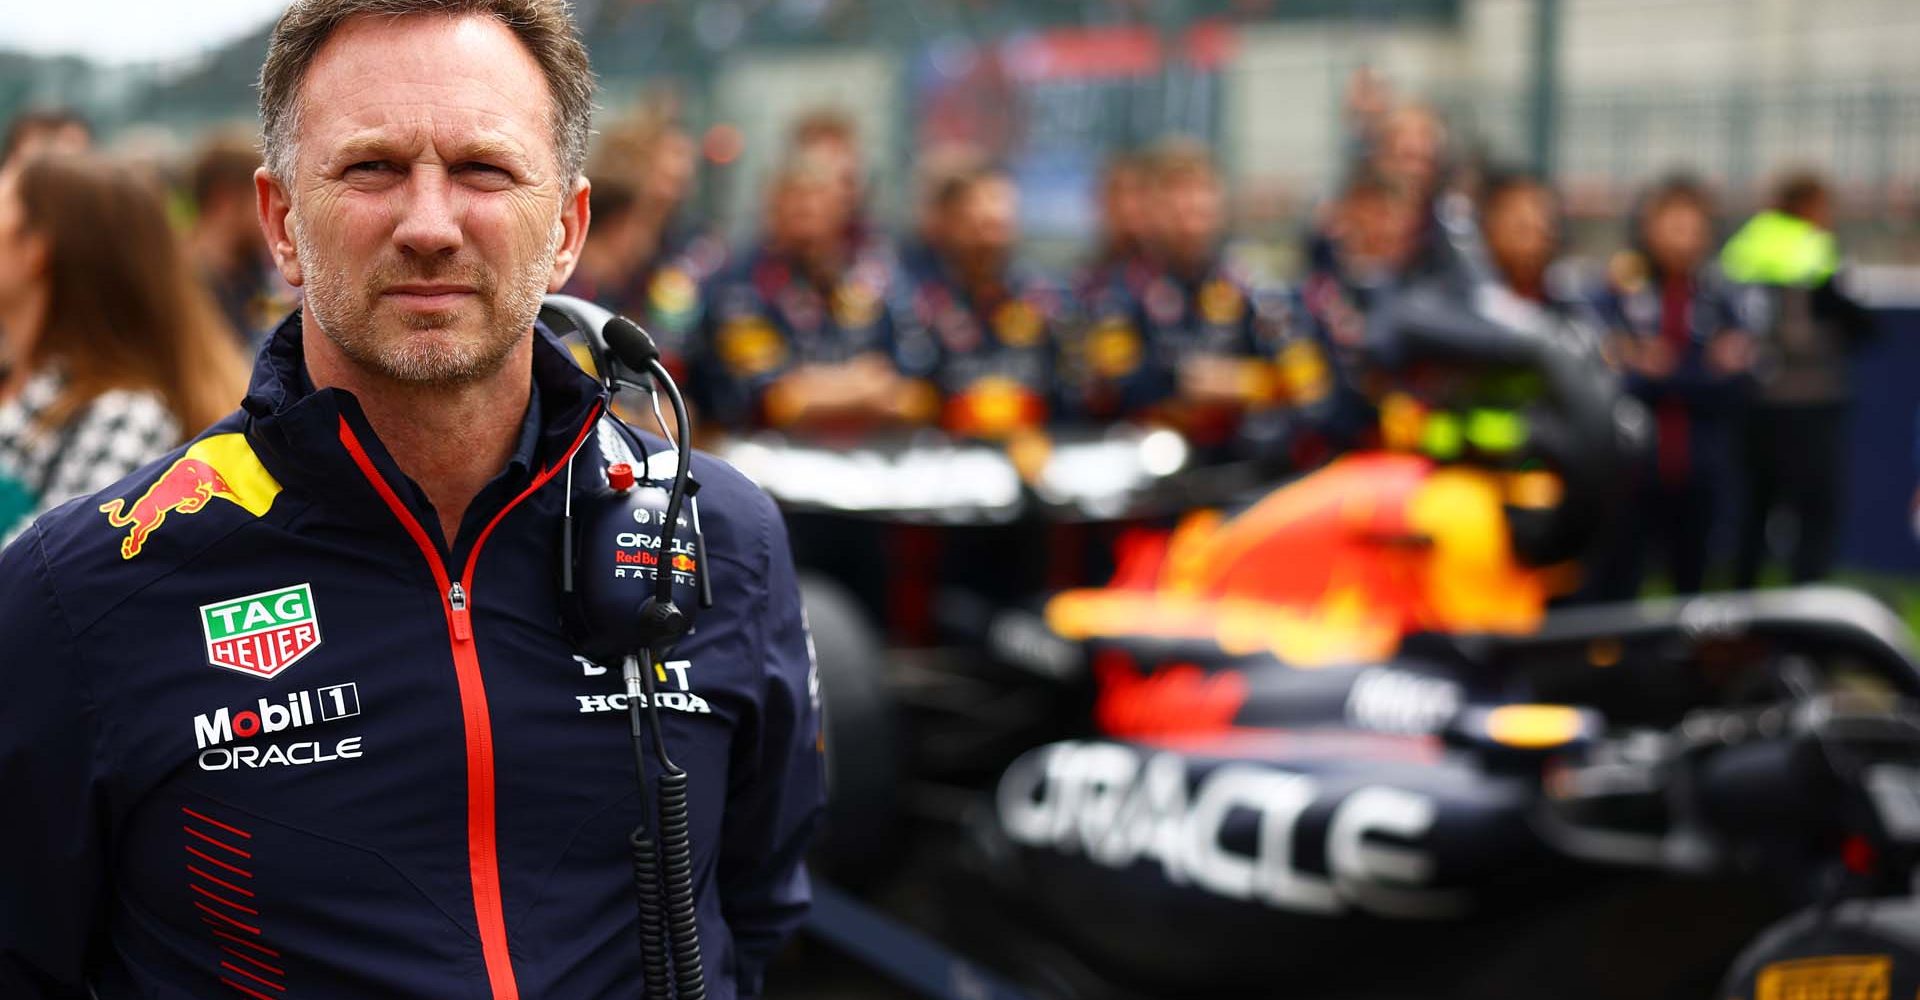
top-left (259, 0), bottom-right (593, 180)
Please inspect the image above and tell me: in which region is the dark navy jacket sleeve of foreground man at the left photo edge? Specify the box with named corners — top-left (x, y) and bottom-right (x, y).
top-left (0, 528), bottom-right (108, 1000)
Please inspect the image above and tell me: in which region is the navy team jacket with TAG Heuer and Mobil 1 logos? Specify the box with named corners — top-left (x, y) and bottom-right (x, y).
top-left (0, 315), bottom-right (824, 1000)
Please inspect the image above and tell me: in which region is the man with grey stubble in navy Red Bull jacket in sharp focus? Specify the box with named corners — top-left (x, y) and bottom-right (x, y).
top-left (0, 0), bottom-right (822, 1000)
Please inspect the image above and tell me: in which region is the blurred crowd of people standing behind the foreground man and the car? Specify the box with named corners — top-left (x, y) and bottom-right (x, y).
top-left (0, 77), bottom-right (1872, 599)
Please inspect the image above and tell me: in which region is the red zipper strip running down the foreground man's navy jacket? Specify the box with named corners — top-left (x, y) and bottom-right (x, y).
top-left (340, 407), bottom-right (601, 1000)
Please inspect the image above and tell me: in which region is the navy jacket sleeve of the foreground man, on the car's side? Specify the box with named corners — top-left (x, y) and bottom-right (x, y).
top-left (720, 495), bottom-right (826, 996)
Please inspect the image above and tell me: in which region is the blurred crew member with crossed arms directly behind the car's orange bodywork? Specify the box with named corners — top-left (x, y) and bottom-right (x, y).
top-left (1085, 144), bottom-right (1332, 457)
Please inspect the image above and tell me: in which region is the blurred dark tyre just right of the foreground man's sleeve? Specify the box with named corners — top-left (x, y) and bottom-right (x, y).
top-left (801, 574), bottom-right (904, 889)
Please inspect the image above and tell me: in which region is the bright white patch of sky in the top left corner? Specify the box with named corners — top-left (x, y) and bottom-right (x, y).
top-left (0, 0), bottom-right (286, 63)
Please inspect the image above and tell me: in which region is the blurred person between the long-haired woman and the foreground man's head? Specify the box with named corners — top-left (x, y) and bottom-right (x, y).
top-left (186, 138), bottom-right (294, 344)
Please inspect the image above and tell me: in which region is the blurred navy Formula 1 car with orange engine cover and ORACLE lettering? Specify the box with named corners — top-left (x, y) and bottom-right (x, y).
top-left (729, 206), bottom-right (1920, 1000)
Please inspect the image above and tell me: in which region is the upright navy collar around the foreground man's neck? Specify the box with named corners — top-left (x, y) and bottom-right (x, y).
top-left (242, 309), bottom-right (601, 520)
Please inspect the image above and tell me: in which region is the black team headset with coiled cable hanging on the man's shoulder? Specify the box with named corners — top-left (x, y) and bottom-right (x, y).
top-left (540, 296), bottom-right (712, 1000)
